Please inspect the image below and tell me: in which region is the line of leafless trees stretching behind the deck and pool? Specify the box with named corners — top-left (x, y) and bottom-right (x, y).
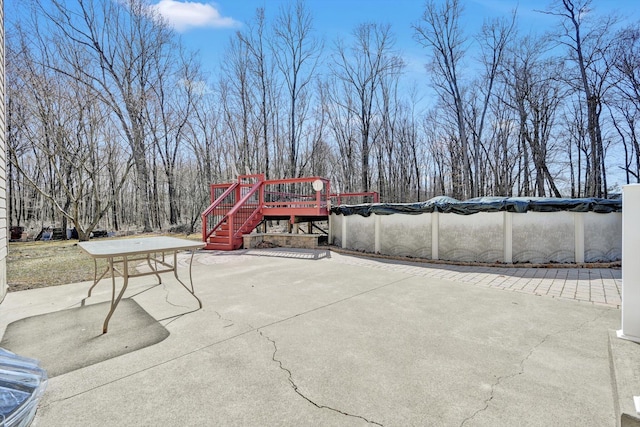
top-left (6, 0), bottom-right (640, 239)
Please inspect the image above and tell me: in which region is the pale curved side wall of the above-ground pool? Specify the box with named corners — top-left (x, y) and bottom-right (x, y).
top-left (331, 211), bottom-right (622, 263)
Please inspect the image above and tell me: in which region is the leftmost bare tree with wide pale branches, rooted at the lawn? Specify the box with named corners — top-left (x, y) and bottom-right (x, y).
top-left (8, 25), bottom-right (132, 240)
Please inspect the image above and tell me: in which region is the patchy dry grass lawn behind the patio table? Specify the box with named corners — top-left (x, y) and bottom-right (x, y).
top-left (7, 233), bottom-right (200, 292)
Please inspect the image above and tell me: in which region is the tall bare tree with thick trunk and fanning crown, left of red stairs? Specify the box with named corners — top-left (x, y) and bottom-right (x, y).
top-left (39, 0), bottom-right (172, 231)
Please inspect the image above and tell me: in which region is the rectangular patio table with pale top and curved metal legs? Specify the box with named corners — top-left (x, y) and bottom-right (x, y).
top-left (78, 237), bottom-right (204, 334)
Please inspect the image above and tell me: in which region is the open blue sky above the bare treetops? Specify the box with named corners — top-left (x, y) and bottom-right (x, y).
top-left (152, 0), bottom-right (640, 81)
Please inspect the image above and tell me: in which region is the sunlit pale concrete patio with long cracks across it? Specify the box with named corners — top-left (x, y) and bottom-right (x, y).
top-left (0, 249), bottom-right (620, 426)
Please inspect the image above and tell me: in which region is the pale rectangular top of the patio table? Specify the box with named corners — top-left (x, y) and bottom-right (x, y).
top-left (78, 236), bottom-right (204, 258)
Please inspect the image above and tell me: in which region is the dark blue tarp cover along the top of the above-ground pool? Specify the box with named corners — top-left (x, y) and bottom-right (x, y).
top-left (331, 196), bottom-right (622, 217)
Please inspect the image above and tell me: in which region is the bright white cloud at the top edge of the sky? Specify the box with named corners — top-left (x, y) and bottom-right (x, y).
top-left (153, 0), bottom-right (240, 31)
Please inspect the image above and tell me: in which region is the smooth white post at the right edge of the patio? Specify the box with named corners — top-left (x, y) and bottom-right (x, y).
top-left (618, 184), bottom-right (640, 343)
